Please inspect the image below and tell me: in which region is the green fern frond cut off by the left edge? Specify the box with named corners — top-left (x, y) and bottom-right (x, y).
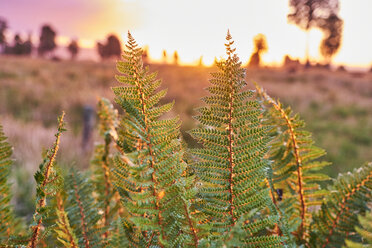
top-left (0, 125), bottom-right (17, 243)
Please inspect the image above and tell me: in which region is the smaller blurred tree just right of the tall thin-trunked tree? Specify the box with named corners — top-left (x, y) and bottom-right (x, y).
top-left (319, 14), bottom-right (344, 64)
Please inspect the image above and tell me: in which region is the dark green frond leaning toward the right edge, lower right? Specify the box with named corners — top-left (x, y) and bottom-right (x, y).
top-left (311, 163), bottom-right (372, 248)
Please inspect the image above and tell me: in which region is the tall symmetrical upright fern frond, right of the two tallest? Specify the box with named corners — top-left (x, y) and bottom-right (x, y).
top-left (190, 33), bottom-right (282, 247)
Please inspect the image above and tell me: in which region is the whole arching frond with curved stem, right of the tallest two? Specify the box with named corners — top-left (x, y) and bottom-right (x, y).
top-left (256, 84), bottom-right (329, 240)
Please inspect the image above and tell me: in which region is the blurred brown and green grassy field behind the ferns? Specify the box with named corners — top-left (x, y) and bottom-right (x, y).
top-left (0, 57), bottom-right (372, 179)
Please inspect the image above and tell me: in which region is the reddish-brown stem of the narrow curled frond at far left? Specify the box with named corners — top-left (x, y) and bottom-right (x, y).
top-left (27, 112), bottom-right (65, 248)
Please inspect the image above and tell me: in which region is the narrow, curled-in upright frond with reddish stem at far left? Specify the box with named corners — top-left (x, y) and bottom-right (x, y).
top-left (27, 112), bottom-right (66, 248)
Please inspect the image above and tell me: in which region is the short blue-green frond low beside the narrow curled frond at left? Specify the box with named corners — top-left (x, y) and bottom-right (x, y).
top-left (65, 170), bottom-right (106, 248)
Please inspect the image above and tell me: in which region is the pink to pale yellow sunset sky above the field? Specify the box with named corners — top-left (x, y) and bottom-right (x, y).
top-left (0, 0), bottom-right (372, 67)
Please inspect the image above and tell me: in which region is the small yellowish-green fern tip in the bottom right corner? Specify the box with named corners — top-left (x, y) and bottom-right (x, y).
top-left (345, 208), bottom-right (372, 248)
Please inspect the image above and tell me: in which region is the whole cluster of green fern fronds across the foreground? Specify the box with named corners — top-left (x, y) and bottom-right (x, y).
top-left (0, 33), bottom-right (372, 248)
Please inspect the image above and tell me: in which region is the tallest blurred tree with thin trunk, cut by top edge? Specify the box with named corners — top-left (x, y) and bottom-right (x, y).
top-left (287, 0), bottom-right (339, 64)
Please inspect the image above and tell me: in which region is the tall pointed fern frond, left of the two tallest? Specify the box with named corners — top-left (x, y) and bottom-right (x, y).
top-left (113, 33), bottom-right (203, 247)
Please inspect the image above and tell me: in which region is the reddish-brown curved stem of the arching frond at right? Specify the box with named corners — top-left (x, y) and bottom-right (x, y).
top-left (256, 85), bottom-right (306, 239)
